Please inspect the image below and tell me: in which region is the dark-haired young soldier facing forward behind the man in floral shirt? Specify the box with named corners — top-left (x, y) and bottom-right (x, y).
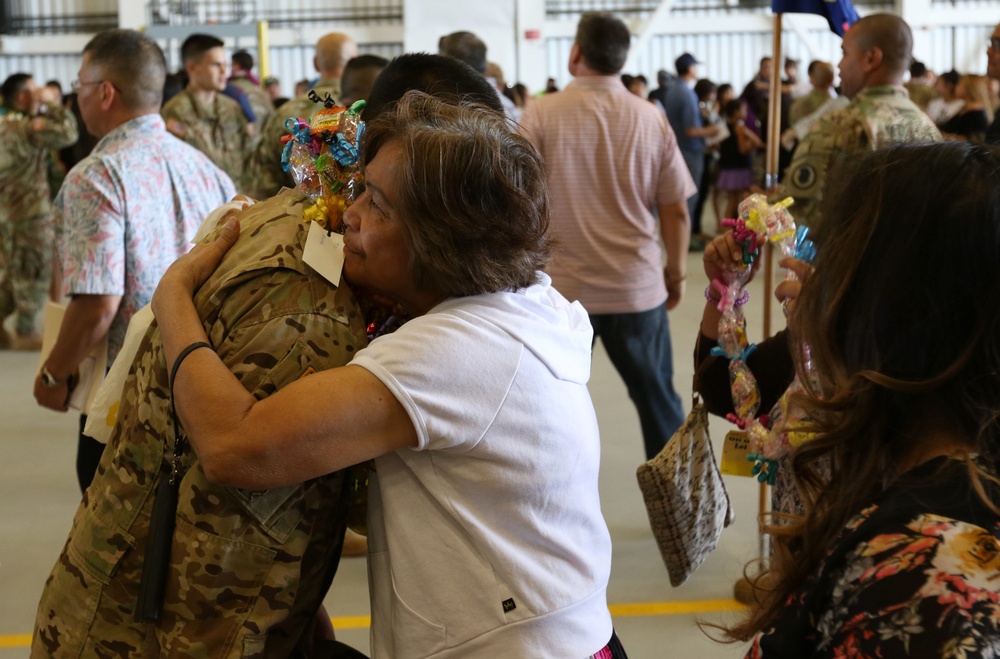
top-left (161, 34), bottom-right (250, 192)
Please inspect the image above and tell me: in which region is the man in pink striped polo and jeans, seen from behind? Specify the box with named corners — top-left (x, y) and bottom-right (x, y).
top-left (521, 12), bottom-right (697, 458)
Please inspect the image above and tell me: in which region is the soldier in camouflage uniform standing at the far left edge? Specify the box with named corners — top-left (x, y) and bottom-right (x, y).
top-left (0, 73), bottom-right (78, 348)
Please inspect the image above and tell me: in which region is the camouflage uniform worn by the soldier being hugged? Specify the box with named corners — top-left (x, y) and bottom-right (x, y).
top-left (32, 190), bottom-right (367, 659)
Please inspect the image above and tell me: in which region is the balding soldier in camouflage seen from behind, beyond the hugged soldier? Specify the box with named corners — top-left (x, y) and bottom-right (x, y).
top-left (248, 32), bottom-right (358, 199)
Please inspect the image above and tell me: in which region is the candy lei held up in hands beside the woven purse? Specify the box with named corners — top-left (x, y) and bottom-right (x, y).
top-left (711, 194), bottom-right (815, 484)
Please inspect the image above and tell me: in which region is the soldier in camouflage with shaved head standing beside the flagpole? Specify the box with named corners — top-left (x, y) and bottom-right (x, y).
top-left (782, 14), bottom-right (941, 232)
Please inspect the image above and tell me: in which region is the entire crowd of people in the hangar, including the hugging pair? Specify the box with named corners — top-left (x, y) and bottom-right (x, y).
top-left (0, 6), bottom-right (1000, 659)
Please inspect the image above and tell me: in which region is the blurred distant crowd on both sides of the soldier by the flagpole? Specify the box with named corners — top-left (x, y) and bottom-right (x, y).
top-left (608, 27), bottom-right (1000, 251)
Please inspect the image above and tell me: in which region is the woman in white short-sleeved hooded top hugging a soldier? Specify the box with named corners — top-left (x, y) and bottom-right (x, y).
top-left (153, 92), bottom-right (624, 659)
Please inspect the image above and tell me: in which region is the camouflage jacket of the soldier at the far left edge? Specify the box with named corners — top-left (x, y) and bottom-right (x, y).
top-left (0, 106), bottom-right (79, 222)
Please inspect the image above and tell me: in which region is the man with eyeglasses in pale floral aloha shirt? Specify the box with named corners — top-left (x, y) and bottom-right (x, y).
top-left (34, 30), bottom-right (235, 491)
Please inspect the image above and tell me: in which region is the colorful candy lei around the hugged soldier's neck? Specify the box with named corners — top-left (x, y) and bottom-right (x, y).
top-left (281, 91), bottom-right (365, 231)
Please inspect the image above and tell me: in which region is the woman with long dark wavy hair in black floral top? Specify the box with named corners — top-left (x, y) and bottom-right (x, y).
top-left (728, 143), bottom-right (1000, 658)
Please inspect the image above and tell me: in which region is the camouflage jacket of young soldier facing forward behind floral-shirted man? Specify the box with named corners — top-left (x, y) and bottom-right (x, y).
top-left (160, 87), bottom-right (250, 192)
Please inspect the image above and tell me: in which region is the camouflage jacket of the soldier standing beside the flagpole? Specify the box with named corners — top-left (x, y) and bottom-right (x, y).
top-left (781, 85), bottom-right (941, 227)
